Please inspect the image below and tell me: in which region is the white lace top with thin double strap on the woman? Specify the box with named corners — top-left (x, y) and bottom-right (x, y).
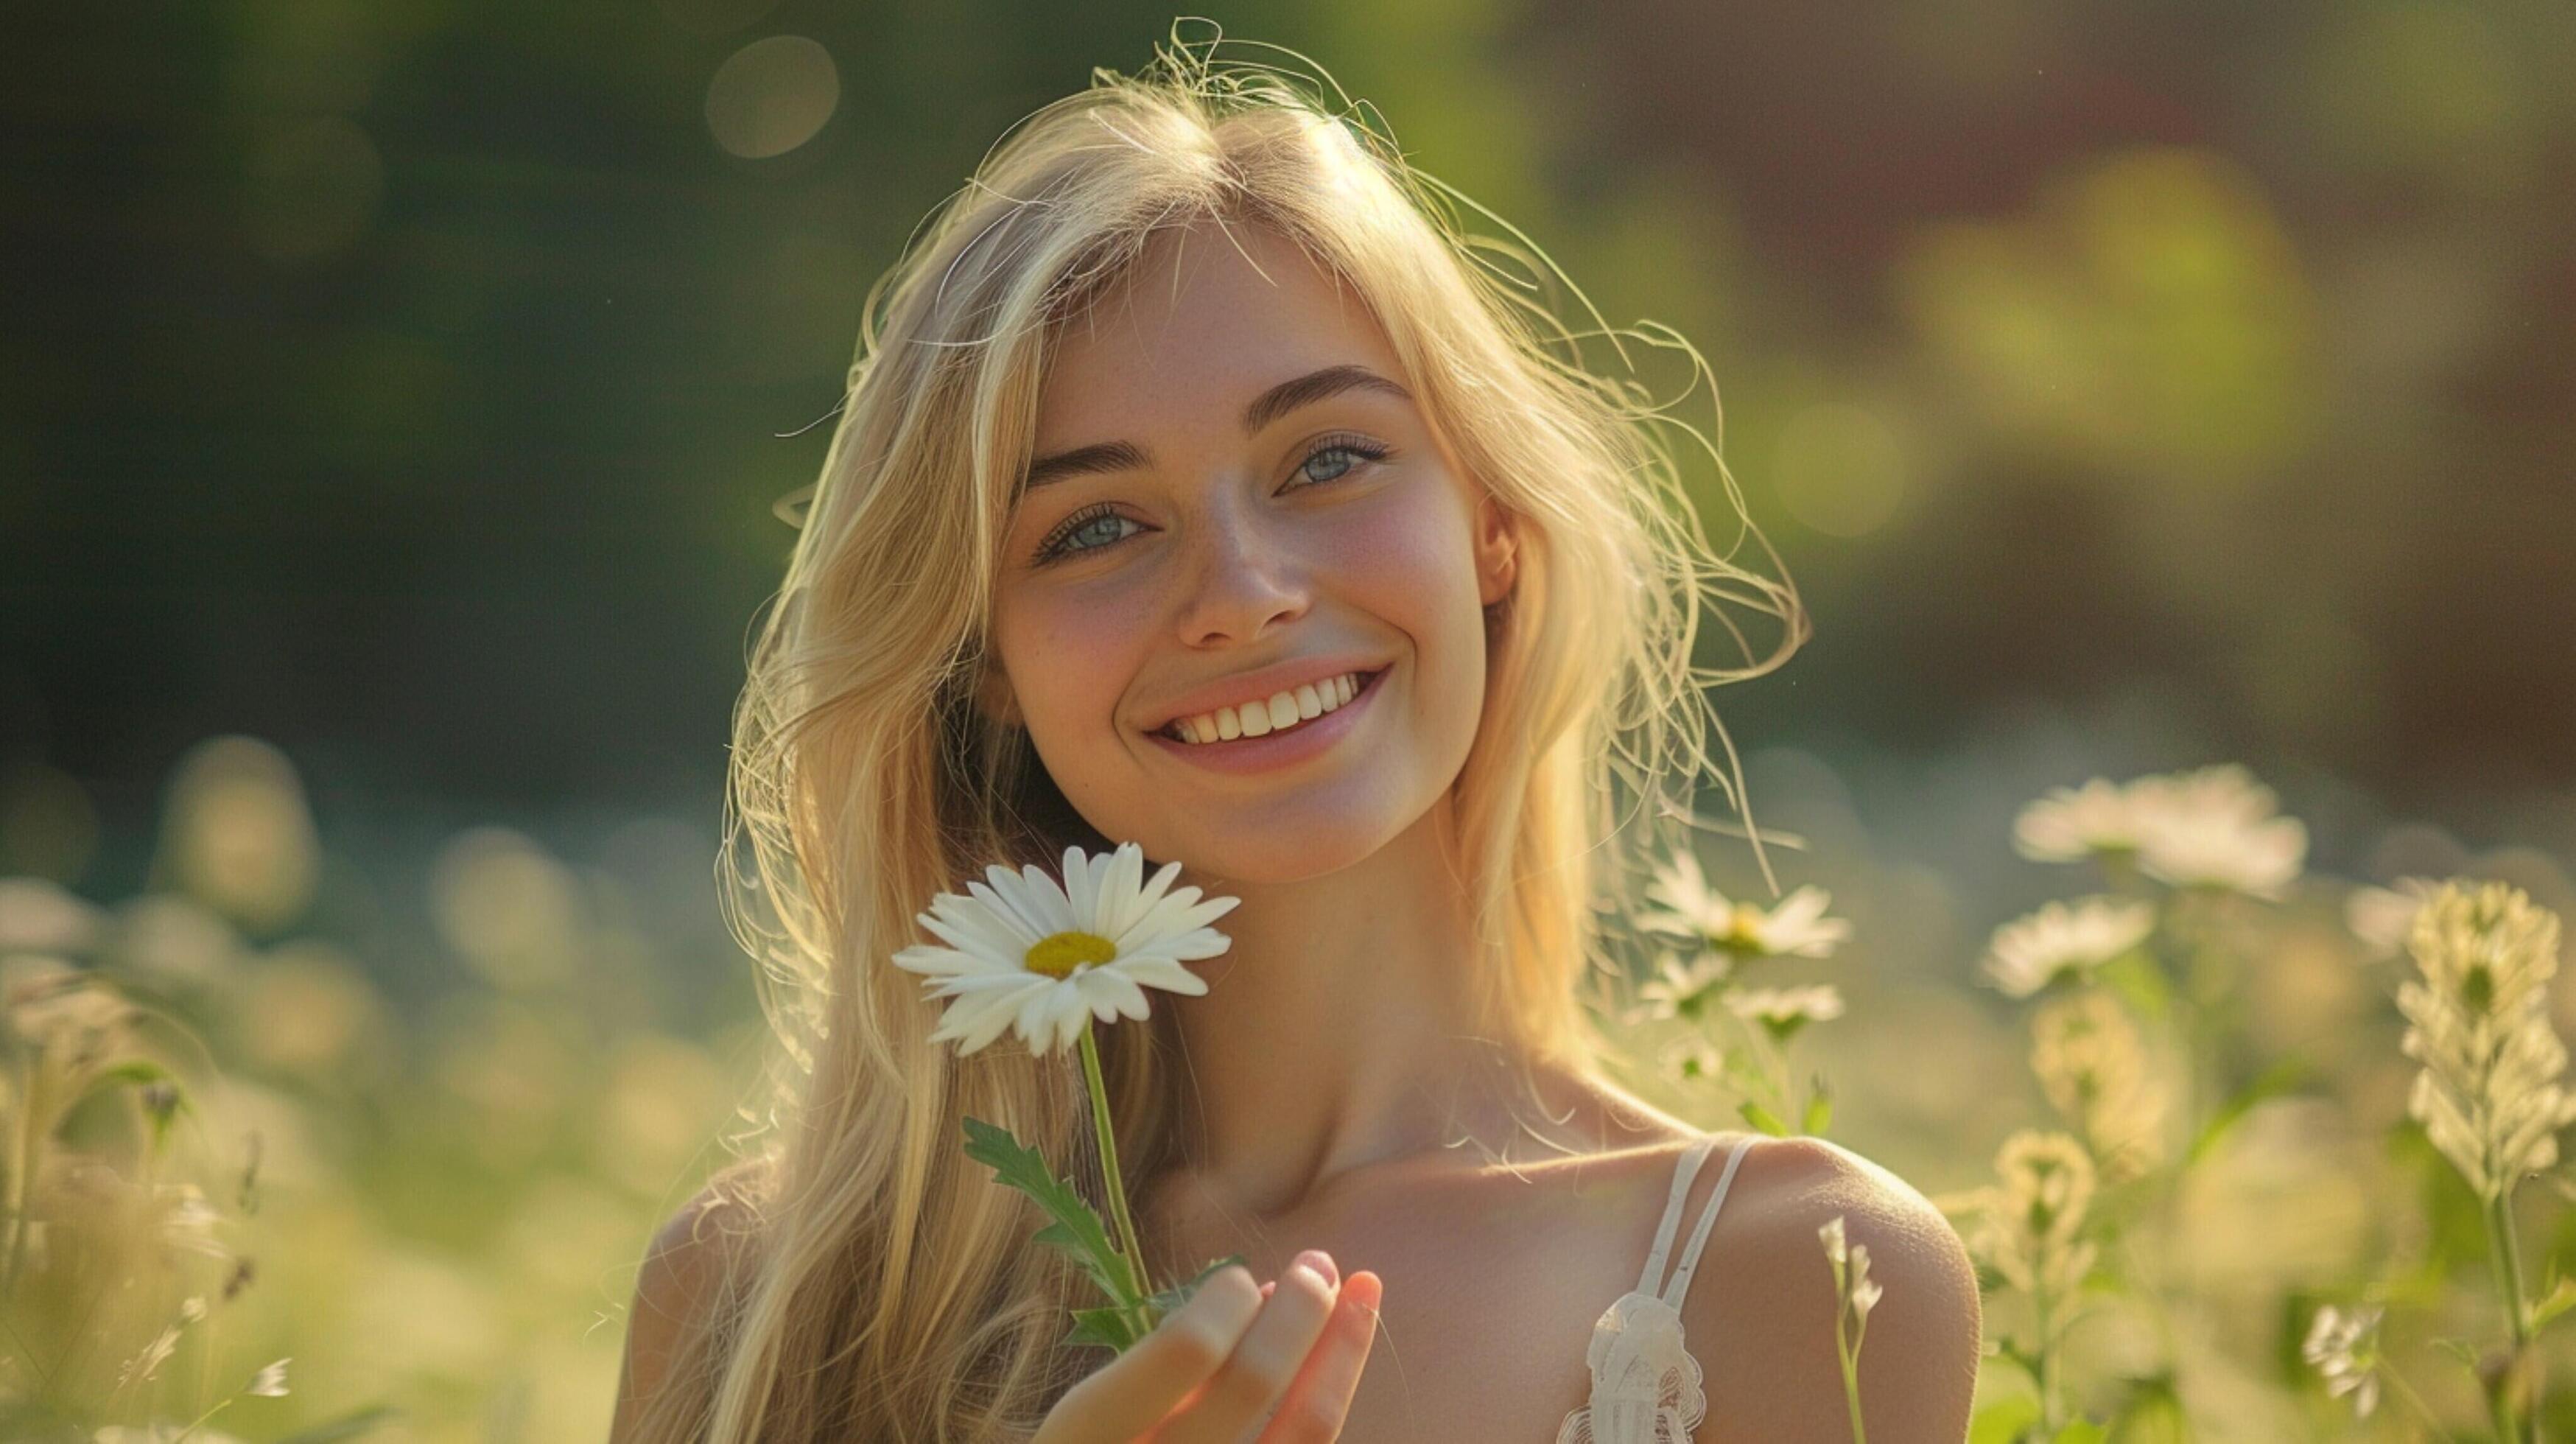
top-left (1556, 1135), bottom-right (1759, 1444)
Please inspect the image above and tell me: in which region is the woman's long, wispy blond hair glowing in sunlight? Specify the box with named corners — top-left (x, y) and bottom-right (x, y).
top-left (647, 24), bottom-right (1808, 1444)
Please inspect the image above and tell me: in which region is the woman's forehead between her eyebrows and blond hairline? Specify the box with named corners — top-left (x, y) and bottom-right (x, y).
top-left (1036, 222), bottom-right (1404, 454)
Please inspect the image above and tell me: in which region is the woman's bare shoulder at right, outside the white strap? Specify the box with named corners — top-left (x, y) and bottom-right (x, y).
top-left (1682, 1138), bottom-right (1984, 1444)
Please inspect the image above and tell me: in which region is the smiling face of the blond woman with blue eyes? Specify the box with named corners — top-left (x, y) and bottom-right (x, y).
top-left (984, 227), bottom-right (1512, 882)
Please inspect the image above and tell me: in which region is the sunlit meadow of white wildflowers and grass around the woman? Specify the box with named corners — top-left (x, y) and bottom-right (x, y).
top-left (0, 737), bottom-right (2576, 1444)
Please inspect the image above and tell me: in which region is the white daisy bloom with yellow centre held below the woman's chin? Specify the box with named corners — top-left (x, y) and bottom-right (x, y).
top-left (894, 844), bottom-right (1242, 1057)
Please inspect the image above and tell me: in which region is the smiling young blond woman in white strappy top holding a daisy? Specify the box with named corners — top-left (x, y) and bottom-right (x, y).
top-left (616, 25), bottom-right (1979, 1444)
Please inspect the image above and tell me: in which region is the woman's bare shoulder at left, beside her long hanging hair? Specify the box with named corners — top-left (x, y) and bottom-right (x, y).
top-left (608, 1166), bottom-right (757, 1444)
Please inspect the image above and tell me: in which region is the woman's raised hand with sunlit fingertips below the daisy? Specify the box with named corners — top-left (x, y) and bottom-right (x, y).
top-left (1031, 1248), bottom-right (1380, 1444)
